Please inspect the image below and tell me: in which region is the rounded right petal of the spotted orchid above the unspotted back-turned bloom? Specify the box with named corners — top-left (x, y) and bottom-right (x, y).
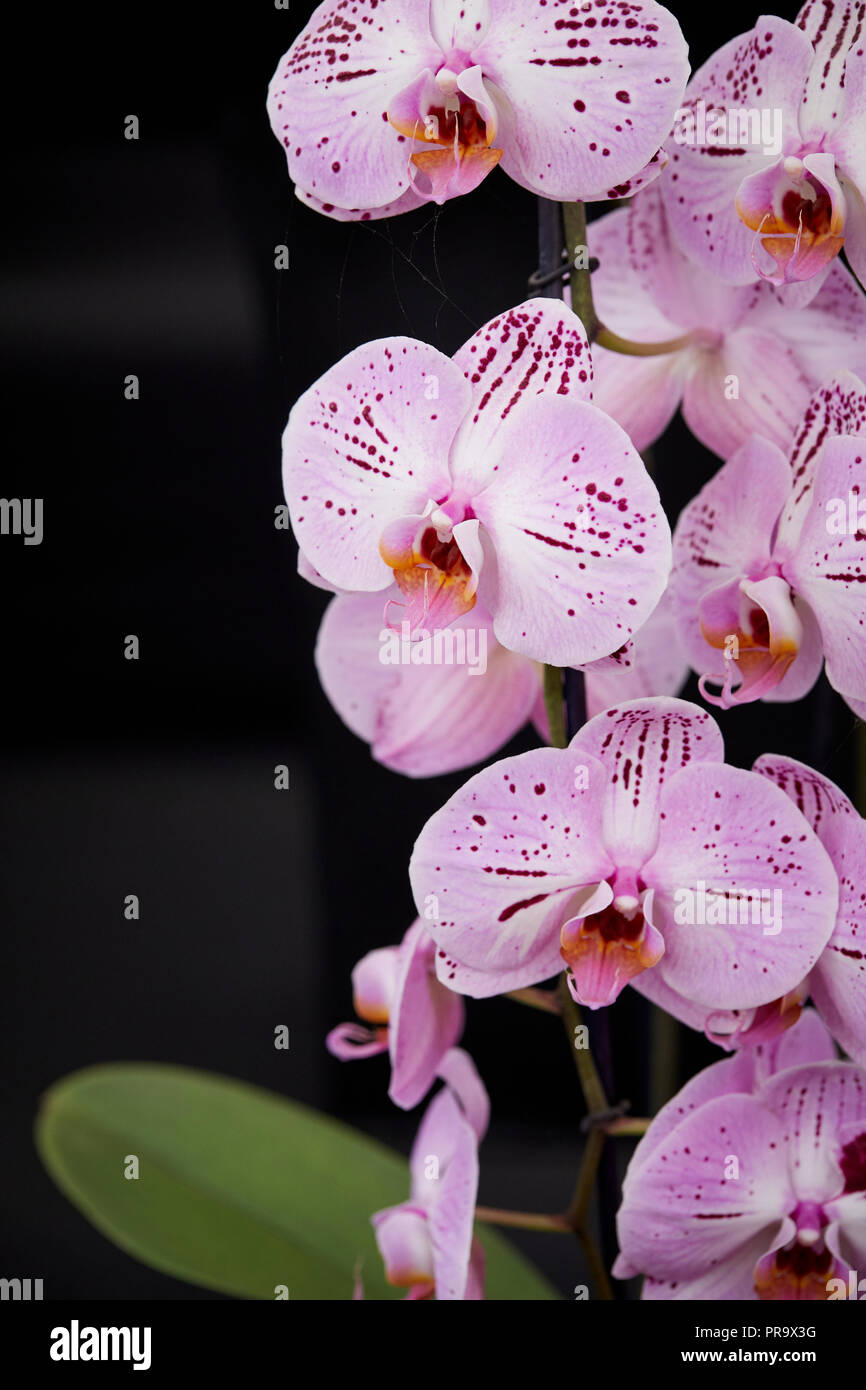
top-left (474, 395), bottom-right (670, 666)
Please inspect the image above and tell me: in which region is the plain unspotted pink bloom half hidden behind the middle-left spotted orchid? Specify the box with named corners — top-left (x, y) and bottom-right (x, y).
top-left (316, 575), bottom-right (689, 777)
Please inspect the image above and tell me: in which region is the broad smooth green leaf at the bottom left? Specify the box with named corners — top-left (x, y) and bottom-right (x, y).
top-left (36, 1063), bottom-right (557, 1300)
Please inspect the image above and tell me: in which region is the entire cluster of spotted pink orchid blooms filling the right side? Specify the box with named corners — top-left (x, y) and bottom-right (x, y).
top-left (268, 0), bottom-right (866, 1300)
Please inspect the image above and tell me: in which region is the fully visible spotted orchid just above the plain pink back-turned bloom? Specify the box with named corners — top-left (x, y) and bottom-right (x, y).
top-left (284, 299), bottom-right (670, 666)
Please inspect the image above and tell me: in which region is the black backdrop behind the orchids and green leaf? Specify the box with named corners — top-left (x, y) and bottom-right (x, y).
top-left (0, 0), bottom-right (855, 1298)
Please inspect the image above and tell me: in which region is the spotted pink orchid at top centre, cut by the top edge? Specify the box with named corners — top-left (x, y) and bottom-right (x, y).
top-left (268, 0), bottom-right (688, 220)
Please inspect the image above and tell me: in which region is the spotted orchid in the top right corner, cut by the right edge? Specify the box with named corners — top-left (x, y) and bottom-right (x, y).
top-left (664, 0), bottom-right (866, 302)
